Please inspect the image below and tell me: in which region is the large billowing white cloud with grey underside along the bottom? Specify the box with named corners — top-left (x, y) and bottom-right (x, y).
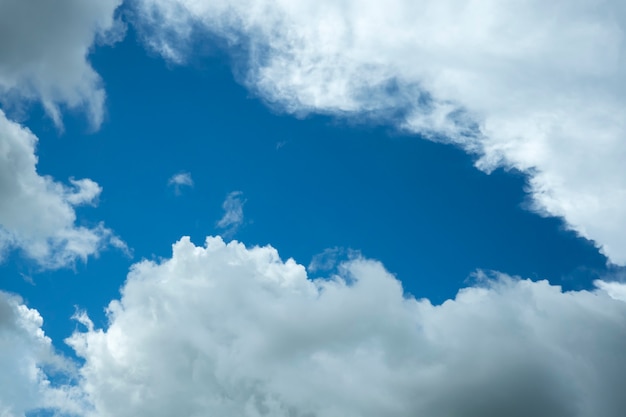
top-left (68, 238), bottom-right (626, 417)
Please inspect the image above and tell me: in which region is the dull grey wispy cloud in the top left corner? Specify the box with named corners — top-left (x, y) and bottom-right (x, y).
top-left (0, 0), bottom-right (124, 128)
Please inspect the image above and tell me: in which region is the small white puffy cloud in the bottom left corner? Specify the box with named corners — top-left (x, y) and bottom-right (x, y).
top-left (0, 291), bottom-right (85, 417)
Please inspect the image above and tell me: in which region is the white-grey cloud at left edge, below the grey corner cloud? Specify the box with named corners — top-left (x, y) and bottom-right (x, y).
top-left (0, 110), bottom-right (125, 268)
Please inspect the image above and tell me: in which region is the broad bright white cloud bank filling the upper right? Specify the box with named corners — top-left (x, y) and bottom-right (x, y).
top-left (136, 0), bottom-right (626, 263)
